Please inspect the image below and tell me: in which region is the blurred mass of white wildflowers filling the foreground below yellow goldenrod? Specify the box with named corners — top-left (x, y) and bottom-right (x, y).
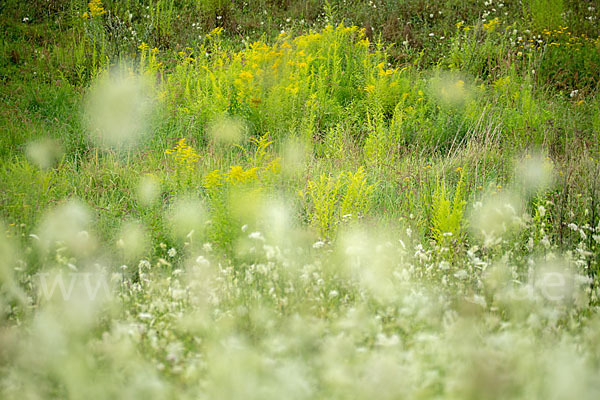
top-left (0, 185), bottom-right (600, 399)
